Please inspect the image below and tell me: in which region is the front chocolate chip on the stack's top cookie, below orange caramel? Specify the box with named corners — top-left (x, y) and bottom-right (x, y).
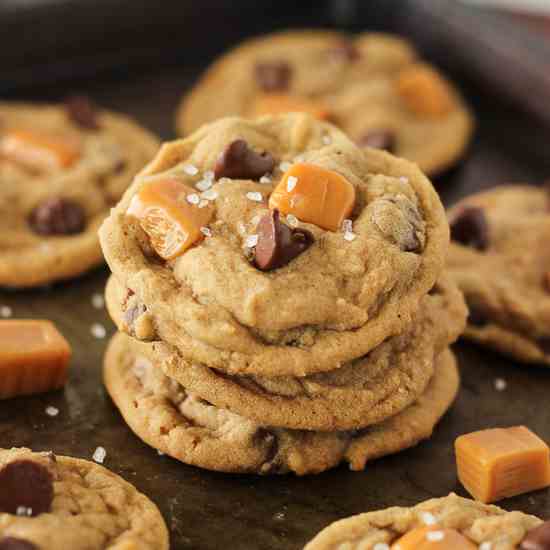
top-left (254, 210), bottom-right (314, 271)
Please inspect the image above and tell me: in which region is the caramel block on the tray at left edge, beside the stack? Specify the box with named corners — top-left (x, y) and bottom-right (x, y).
top-left (0, 319), bottom-right (71, 399)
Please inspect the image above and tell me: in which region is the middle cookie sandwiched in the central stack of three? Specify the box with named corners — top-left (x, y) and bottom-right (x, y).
top-left (106, 277), bottom-right (466, 430)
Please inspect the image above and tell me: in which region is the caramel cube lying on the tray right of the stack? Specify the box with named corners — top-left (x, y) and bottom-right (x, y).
top-left (455, 426), bottom-right (550, 503)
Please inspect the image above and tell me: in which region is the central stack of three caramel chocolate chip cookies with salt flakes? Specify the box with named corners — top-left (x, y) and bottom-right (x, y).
top-left (100, 114), bottom-right (466, 474)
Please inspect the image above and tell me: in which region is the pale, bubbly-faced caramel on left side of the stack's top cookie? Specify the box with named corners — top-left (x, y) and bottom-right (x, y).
top-left (127, 179), bottom-right (213, 260)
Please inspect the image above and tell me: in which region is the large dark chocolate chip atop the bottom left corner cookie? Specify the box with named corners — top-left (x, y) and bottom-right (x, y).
top-left (0, 460), bottom-right (53, 516)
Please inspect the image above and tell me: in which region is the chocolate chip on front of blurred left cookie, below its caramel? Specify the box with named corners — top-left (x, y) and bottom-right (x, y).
top-left (29, 197), bottom-right (85, 235)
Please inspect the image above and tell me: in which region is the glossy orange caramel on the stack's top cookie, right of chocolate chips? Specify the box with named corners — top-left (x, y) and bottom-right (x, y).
top-left (269, 164), bottom-right (355, 231)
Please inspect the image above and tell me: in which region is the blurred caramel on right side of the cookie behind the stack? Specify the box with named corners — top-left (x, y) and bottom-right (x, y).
top-left (397, 64), bottom-right (453, 117)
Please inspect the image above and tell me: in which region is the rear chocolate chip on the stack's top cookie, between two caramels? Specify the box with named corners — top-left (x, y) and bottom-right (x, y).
top-left (214, 139), bottom-right (275, 180)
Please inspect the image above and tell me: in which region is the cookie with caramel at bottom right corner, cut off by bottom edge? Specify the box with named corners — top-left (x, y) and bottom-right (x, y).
top-left (304, 493), bottom-right (543, 550)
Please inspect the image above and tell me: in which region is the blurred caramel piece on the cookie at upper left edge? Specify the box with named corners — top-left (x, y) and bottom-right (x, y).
top-left (0, 130), bottom-right (80, 172)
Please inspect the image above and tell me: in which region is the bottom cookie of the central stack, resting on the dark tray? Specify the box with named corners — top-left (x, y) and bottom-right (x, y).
top-left (104, 333), bottom-right (459, 475)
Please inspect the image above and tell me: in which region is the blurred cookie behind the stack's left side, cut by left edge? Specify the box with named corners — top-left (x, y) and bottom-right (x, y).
top-left (0, 98), bottom-right (159, 287)
